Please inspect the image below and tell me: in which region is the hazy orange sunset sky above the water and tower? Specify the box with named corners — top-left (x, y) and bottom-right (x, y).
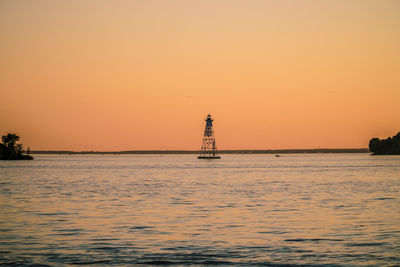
top-left (0, 0), bottom-right (400, 151)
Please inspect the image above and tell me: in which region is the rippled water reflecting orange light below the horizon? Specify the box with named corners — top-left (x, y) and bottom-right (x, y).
top-left (0, 153), bottom-right (400, 266)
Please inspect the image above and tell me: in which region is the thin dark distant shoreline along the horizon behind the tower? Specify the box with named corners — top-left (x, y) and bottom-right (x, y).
top-left (31, 148), bottom-right (370, 155)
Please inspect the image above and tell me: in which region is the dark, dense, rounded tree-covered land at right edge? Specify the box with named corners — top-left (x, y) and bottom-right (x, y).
top-left (369, 132), bottom-right (400, 155)
